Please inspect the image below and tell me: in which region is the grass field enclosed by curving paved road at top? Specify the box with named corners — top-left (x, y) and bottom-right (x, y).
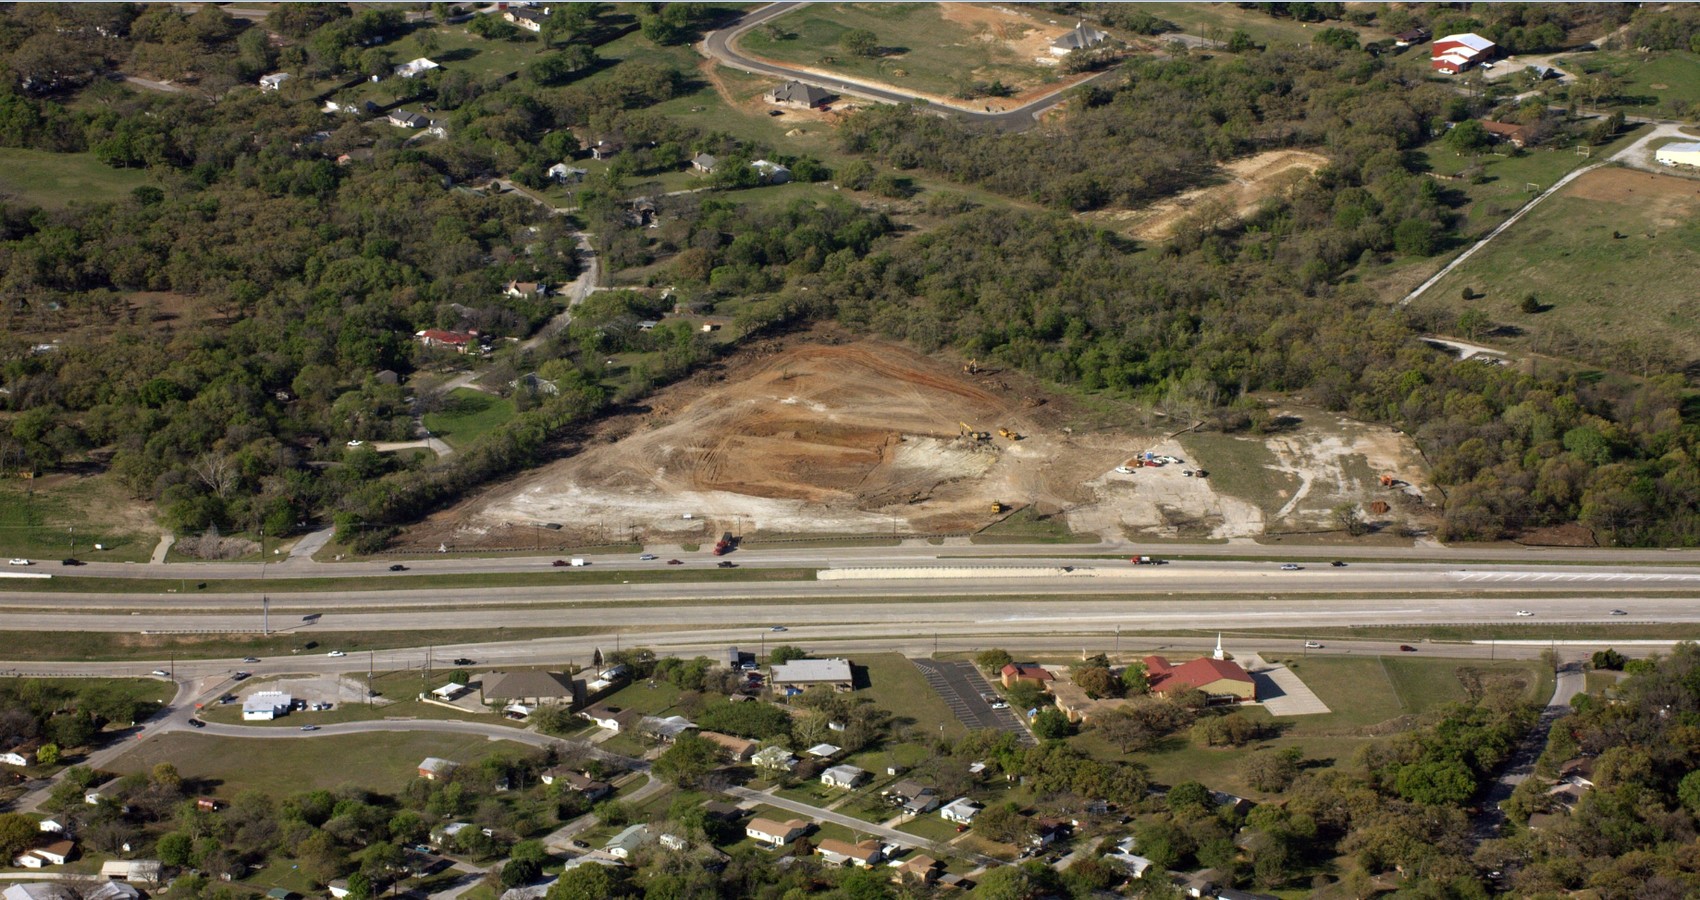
top-left (740, 3), bottom-right (1069, 97)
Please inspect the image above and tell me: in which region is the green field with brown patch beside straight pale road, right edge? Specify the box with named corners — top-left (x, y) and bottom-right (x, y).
top-left (1418, 168), bottom-right (1700, 359)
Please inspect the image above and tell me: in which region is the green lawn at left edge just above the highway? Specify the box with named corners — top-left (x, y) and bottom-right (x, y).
top-left (0, 476), bottom-right (158, 561)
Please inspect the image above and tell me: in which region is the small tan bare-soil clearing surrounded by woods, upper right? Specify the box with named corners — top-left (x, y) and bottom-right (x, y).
top-left (1083, 150), bottom-right (1328, 240)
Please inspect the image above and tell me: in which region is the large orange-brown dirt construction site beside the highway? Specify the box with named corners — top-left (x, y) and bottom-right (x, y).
top-left (418, 335), bottom-right (1441, 550)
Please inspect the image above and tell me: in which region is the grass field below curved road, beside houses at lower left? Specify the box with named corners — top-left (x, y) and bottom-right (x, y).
top-left (112, 732), bottom-right (530, 798)
